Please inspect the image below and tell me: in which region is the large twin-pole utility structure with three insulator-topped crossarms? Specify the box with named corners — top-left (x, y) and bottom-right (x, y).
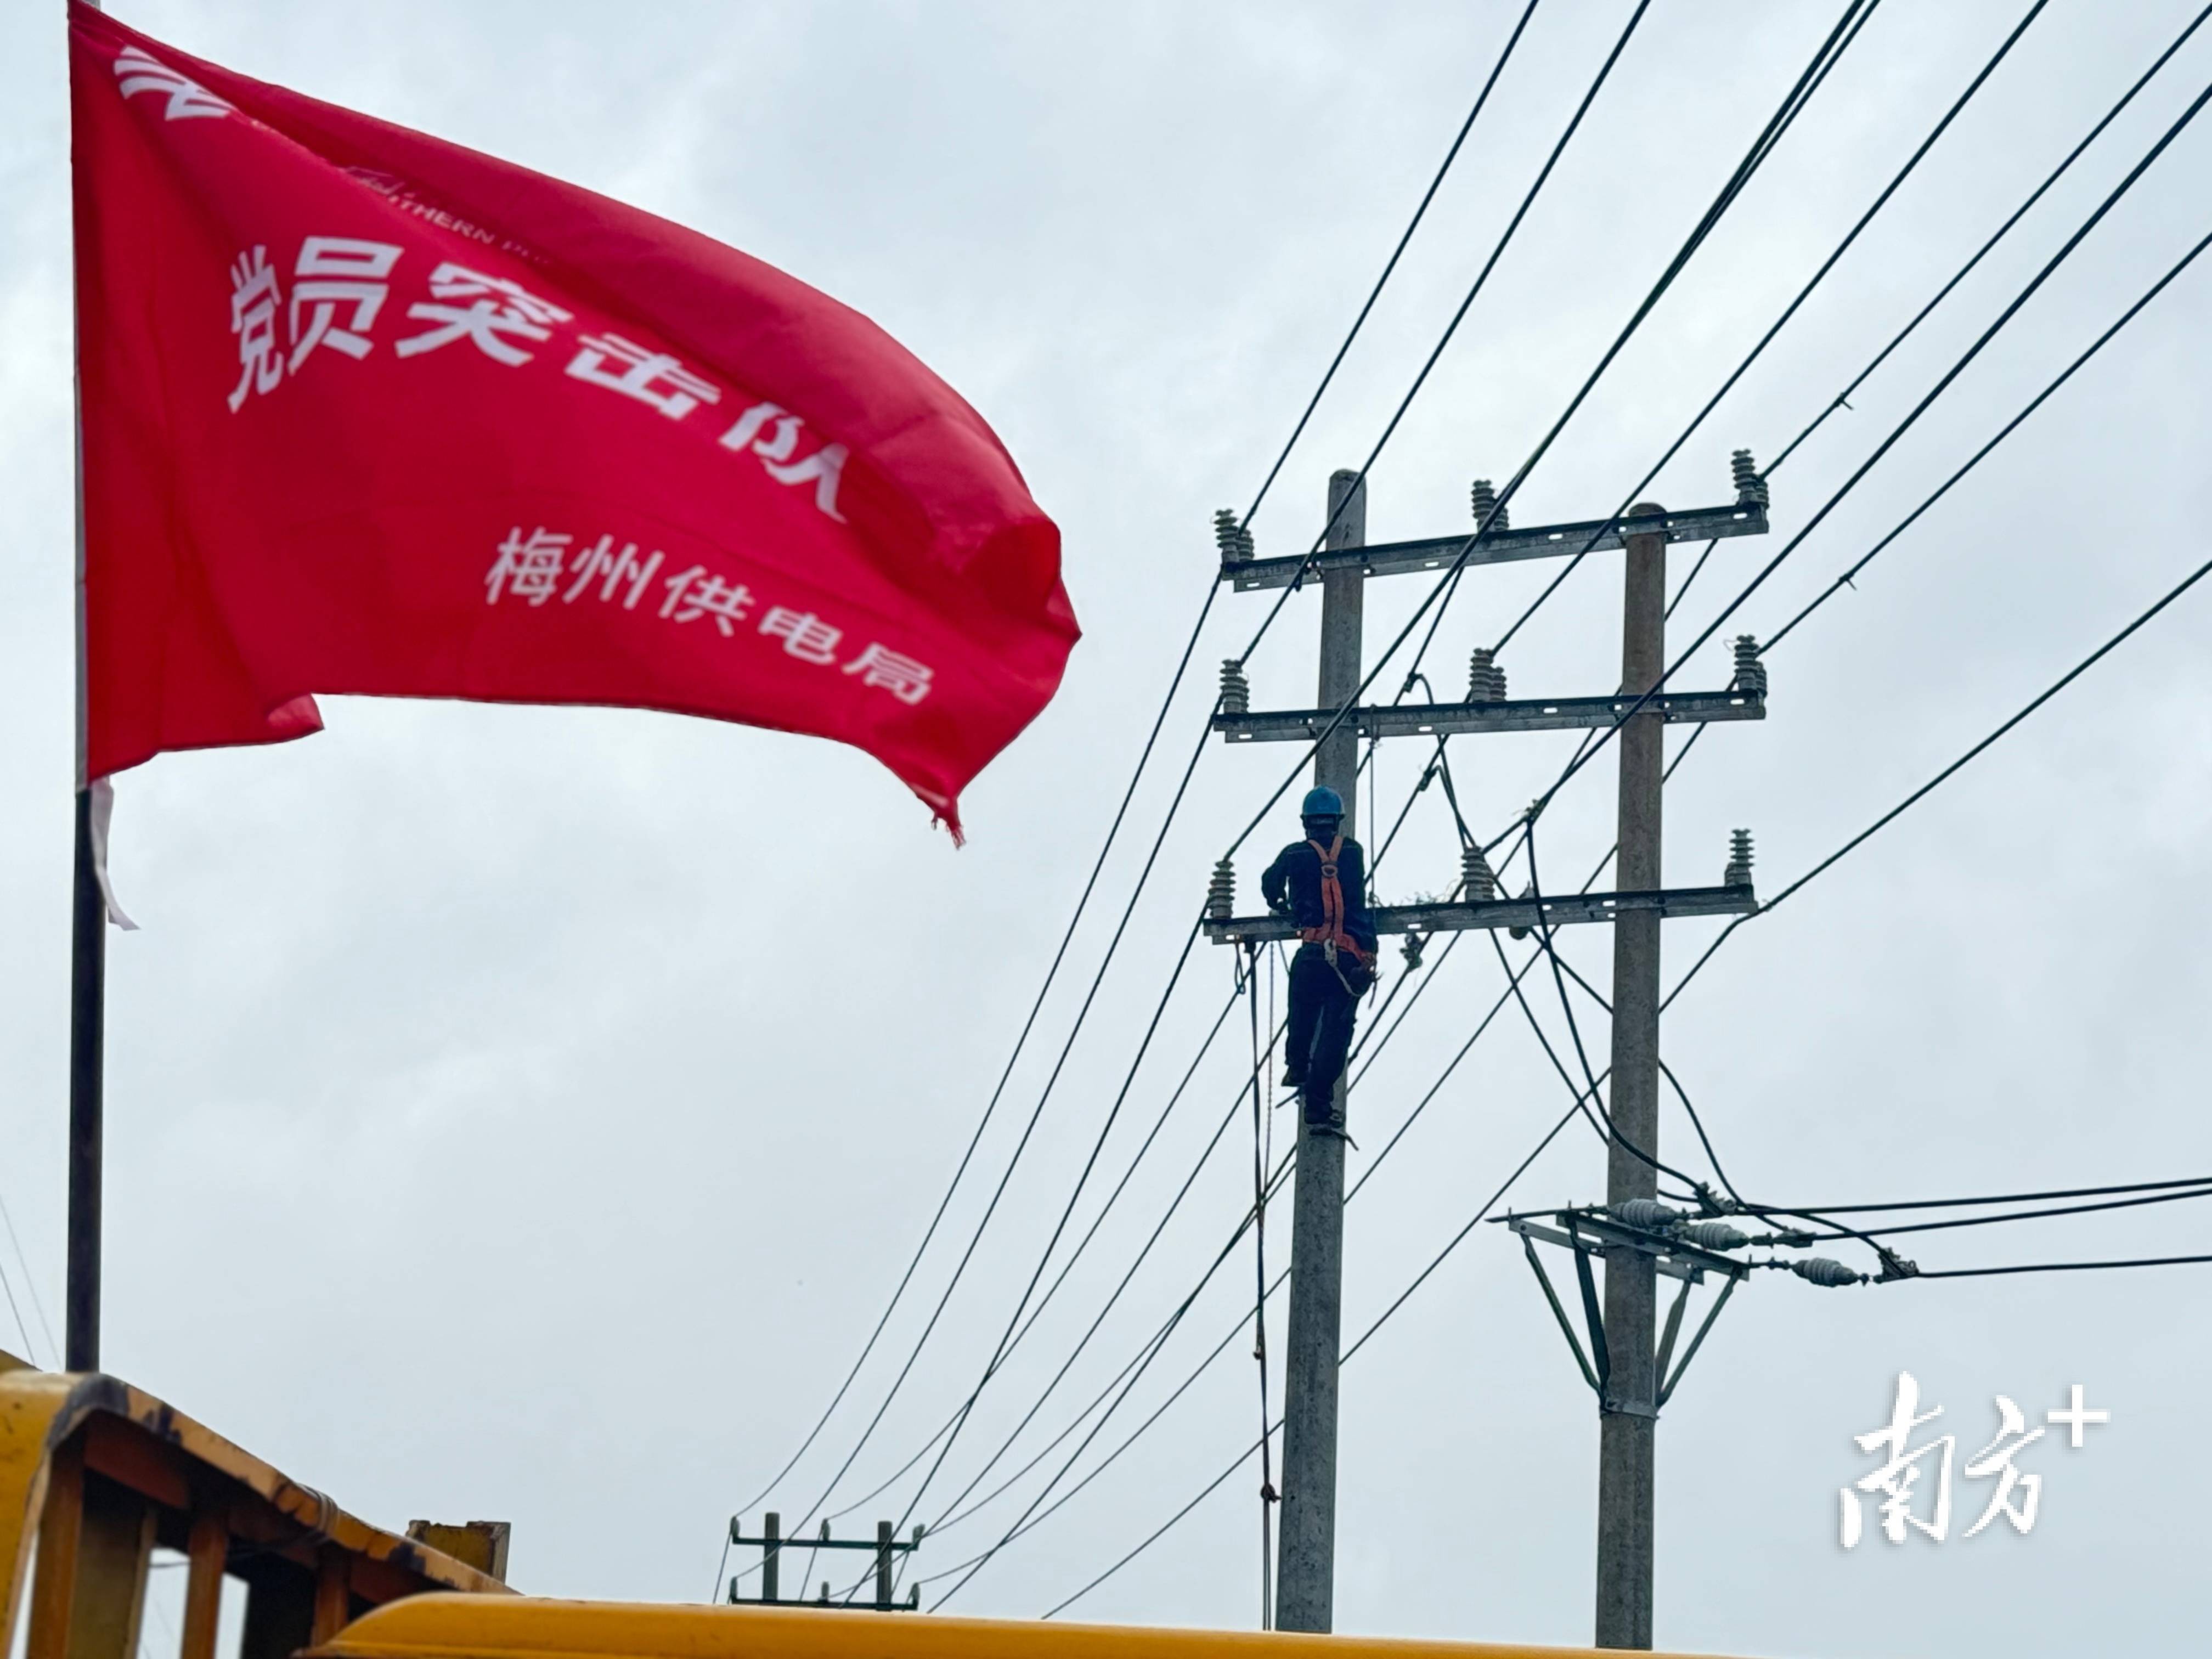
top-left (1203, 449), bottom-right (1769, 1648)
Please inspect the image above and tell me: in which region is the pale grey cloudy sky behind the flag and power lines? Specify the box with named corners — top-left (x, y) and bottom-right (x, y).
top-left (0, 0), bottom-right (2212, 1657)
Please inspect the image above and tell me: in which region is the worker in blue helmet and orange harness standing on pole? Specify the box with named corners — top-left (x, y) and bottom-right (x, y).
top-left (1259, 787), bottom-right (1376, 1137)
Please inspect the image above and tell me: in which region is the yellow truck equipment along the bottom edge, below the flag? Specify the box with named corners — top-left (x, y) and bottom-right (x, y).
top-left (0, 1354), bottom-right (1725, 1659)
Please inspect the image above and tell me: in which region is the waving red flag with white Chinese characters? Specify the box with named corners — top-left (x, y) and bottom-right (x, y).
top-left (69, 4), bottom-right (1077, 834)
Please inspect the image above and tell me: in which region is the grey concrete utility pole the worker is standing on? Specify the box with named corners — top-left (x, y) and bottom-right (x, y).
top-left (1274, 471), bottom-right (1367, 1630)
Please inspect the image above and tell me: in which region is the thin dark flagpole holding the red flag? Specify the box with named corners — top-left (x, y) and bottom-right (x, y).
top-left (62, 0), bottom-right (109, 1372)
